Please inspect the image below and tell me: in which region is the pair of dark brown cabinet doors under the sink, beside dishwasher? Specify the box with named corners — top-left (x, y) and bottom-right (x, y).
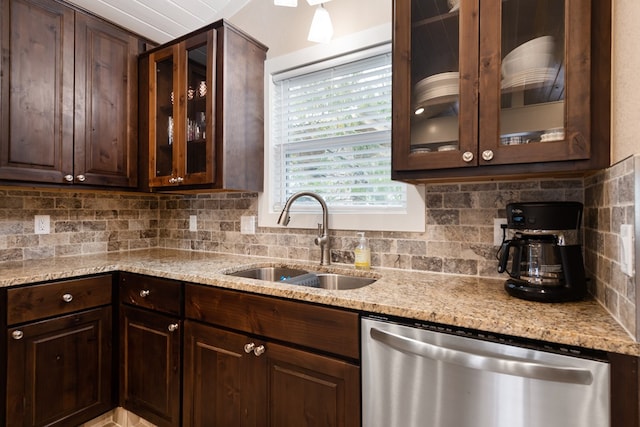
top-left (183, 320), bottom-right (360, 427)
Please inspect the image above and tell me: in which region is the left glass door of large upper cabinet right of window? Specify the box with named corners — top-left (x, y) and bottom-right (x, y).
top-left (393, 0), bottom-right (478, 170)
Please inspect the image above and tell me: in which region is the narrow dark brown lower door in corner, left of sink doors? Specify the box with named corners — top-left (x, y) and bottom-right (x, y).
top-left (120, 306), bottom-right (182, 427)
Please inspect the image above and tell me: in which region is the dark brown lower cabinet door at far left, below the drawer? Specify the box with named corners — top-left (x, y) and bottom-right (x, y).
top-left (5, 307), bottom-right (113, 427)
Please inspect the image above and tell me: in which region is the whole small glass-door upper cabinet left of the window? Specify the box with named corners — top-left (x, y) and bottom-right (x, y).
top-left (139, 21), bottom-right (267, 191)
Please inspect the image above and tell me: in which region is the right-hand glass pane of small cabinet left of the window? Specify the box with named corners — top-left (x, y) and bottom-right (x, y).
top-left (187, 45), bottom-right (211, 174)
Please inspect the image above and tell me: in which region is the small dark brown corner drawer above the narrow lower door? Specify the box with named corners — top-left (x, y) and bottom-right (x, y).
top-left (120, 273), bottom-right (182, 315)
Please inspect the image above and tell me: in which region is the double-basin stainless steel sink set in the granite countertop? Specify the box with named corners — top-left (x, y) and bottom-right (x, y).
top-left (227, 267), bottom-right (376, 290)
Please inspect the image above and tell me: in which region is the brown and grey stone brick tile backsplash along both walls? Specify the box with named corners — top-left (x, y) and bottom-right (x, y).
top-left (0, 158), bottom-right (637, 336)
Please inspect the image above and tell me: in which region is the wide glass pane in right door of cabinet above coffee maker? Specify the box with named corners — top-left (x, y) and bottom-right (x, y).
top-left (500, 0), bottom-right (565, 145)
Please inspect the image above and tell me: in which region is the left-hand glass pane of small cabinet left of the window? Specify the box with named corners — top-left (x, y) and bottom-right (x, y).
top-left (156, 57), bottom-right (173, 177)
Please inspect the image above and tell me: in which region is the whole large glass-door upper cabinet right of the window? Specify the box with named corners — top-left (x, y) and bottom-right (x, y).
top-left (392, 0), bottom-right (611, 182)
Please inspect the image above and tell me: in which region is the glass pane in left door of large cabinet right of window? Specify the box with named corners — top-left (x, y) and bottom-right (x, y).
top-left (411, 0), bottom-right (460, 152)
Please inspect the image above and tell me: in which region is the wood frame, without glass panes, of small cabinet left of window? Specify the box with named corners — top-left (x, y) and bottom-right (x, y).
top-left (139, 21), bottom-right (267, 191)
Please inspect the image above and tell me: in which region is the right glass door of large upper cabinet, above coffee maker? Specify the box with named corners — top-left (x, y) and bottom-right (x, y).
top-left (478, 0), bottom-right (591, 165)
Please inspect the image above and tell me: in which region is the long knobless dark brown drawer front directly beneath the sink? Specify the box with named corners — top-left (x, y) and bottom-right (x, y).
top-left (185, 285), bottom-right (359, 359)
